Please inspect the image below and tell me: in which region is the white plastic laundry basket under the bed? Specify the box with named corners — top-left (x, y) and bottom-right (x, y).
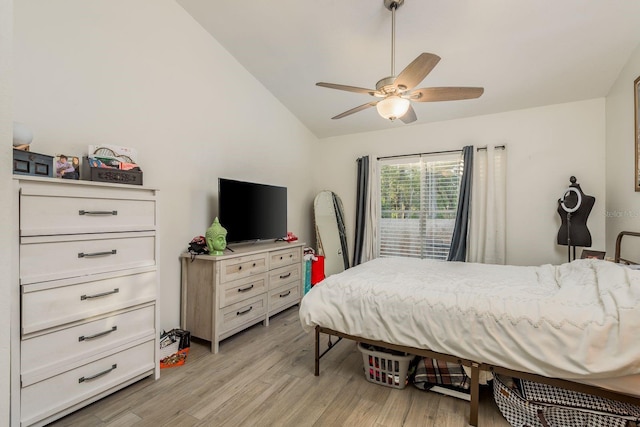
top-left (358, 343), bottom-right (415, 389)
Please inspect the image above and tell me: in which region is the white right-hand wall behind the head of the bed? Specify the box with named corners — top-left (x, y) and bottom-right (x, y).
top-left (606, 41), bottom-right (640, 254)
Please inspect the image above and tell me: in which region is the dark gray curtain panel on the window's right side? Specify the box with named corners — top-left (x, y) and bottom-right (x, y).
top-left (447, 145), bottom-right (473, 261)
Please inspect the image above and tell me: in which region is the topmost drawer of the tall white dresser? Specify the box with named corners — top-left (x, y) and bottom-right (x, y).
top-left (20, 195), bottom-right (156, 236)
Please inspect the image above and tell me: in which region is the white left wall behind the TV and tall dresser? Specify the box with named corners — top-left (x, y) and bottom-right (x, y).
top-left (12, 0), bottom-right (317, 332)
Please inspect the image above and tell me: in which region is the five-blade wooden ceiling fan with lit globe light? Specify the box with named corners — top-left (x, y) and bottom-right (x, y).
top-left (316, 0), bottom-right (484, 123)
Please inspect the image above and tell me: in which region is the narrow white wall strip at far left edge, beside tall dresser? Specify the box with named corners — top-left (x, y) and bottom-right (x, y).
top-left (0, 0), bottom-right (14, 426)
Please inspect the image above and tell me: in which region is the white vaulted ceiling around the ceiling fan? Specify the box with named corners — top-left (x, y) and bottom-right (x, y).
top-left (177, 0), bottom-right (640, 138)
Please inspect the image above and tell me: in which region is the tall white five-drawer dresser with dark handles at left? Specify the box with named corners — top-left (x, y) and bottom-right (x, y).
top-left (11, 178), bottom-right (159, 426)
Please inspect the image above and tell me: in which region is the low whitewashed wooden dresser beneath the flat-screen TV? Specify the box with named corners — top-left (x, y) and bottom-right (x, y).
top-left (181, 242), bottom-right (304, 353)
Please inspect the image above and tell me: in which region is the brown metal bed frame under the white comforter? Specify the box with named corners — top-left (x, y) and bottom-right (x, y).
top-left (314, 231), bottom-right (640, 427)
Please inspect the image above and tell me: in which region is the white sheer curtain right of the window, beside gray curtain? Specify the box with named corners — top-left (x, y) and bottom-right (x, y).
top-left (467, 146), bottom-right (507, 264)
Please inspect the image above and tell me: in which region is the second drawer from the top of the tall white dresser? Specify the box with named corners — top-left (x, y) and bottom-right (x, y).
top-left (20, 232), bottom-right (156, 285)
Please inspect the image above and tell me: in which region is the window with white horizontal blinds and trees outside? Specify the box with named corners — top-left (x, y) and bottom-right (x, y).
top-left (378, 154), bottom-right (463, 260)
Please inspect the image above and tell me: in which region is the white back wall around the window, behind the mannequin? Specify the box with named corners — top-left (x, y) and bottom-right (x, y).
top-left (314, 99), bottom-right (606, 265)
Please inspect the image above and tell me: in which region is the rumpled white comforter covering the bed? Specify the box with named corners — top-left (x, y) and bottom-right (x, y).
top-left (300, 258), bottom-right (640, 379)
